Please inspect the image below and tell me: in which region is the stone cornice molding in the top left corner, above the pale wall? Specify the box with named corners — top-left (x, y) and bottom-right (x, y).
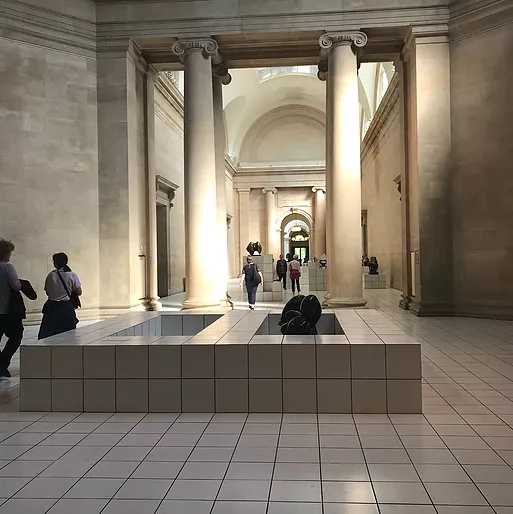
top-left (0, 0), bottom-right (96, 57)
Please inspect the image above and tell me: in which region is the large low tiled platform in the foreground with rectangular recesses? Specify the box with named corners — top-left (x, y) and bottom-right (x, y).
top-left (20, 310), bottom-right (422, 413)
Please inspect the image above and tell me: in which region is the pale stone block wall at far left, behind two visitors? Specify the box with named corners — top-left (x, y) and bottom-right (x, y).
top-left (0, 38), bottom-right (99, 316)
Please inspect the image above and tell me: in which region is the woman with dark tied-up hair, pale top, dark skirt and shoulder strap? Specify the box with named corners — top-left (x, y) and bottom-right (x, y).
top-left (37, 253), bottom-right (82, 339)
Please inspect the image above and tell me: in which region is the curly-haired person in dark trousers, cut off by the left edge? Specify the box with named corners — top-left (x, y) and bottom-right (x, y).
top-left (0, 239), bottom-right (23, 378)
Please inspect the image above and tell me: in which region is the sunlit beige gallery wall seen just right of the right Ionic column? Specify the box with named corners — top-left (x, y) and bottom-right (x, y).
top-left (362, 77), bottom-right (403, 290)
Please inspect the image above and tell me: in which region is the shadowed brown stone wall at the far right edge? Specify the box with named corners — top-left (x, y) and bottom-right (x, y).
top-left (451, 23), bottom-right (513, 318)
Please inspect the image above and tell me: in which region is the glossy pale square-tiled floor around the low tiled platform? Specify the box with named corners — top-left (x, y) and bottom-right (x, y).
top-left (0, 290), bottom-right (513, 514)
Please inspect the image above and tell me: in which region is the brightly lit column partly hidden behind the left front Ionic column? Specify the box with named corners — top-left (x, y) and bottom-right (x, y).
top-left (212, 65), bottom-right (231, 302)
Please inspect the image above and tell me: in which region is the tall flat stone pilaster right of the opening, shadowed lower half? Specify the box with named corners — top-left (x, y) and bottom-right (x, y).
top-left (401, 29), bottom-right (453, 316)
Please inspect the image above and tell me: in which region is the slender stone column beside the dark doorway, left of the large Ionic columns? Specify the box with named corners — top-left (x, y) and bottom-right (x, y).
top-left (144, 67), bottom-right (160, 311)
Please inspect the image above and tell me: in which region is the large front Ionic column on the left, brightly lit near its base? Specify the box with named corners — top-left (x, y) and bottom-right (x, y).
top-left (172, 39), bottom-right (220, 309)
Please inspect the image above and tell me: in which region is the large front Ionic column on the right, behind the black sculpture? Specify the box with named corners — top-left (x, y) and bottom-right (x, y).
top-left (319, 32), bottom-right (367, 307)
